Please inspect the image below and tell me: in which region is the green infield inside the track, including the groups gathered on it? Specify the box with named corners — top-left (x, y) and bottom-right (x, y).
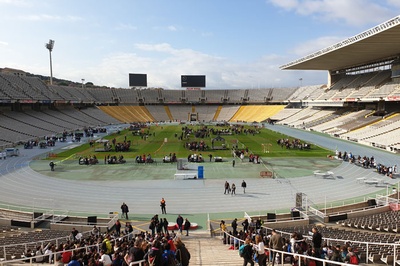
top-left (50, 125), bottom-right (332, 161)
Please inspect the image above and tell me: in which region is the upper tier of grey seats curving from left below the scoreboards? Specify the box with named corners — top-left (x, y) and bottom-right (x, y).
top-left (0, 73), bottom-right (296, 104)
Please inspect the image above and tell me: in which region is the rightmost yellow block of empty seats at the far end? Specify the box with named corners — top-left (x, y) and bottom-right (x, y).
top-left (230, 105), bottom-right (285, 122)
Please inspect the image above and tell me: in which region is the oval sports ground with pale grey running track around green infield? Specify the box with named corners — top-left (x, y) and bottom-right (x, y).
top-left (0, 123), bottom-right (395, 230)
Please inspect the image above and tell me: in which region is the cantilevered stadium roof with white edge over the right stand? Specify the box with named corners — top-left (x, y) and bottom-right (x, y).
top-left (281, 15), bottom-right (400, 71)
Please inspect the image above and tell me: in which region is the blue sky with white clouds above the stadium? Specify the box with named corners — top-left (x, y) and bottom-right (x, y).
top-left (0, 0), bottom-right (400, 89)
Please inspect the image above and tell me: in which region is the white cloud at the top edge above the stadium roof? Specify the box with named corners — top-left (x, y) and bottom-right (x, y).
top-left (268, 0), bottom-right (399, 26)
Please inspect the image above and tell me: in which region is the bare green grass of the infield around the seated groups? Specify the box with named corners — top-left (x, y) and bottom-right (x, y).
top-left (53, 125), bottom-right (331, 160)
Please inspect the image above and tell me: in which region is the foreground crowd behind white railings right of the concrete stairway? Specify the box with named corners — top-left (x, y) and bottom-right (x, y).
top-left (220, 223), bottom-right (360, 266)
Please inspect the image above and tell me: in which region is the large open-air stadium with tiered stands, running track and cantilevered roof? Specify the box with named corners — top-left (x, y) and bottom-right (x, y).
top-left (0, 16), bottom-right (400, 265)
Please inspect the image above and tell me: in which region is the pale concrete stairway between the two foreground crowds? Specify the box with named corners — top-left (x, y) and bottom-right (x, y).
top-left (181, 231), bottom-right (243, 266)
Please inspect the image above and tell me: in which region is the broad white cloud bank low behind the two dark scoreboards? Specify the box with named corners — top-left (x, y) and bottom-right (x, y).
top-left (57, 43), bottom-right (326, 89)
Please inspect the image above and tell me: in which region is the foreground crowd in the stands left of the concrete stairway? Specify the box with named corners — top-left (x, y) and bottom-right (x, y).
top-left (23, 221), bottom-right (190, 266)
